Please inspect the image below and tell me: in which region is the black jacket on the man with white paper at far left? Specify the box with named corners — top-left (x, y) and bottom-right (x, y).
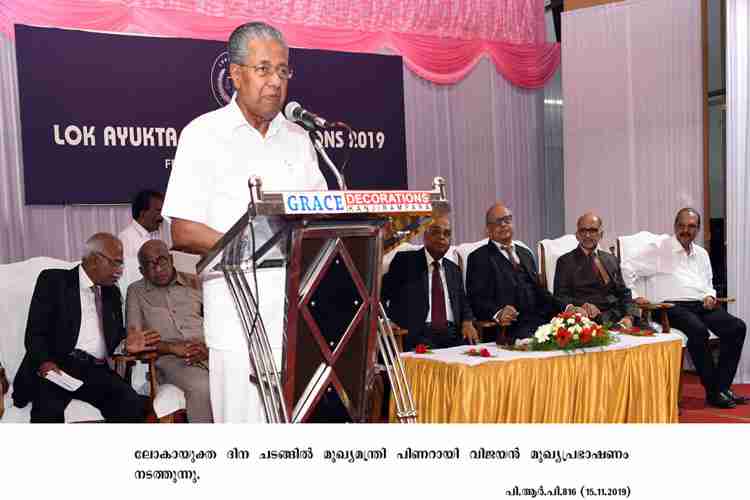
top-left (13, 266), bottom-right (125, 408)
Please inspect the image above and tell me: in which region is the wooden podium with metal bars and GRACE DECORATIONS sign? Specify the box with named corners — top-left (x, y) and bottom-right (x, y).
top-left (198, 178), bottom-right (448, 422)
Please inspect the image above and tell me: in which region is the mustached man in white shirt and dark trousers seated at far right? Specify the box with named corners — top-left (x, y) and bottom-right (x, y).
top-left (622, 208), bottom-right (748, 408)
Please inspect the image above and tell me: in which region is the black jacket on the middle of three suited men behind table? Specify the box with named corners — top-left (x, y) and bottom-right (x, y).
top-left (466, 240), bottom-right (562, 321)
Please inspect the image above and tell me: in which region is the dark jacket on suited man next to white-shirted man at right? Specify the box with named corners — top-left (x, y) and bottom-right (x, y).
top-left (554, 247), bottom-right (638, 316)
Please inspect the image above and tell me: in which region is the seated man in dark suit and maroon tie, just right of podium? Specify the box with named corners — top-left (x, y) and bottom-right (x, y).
top-left (382, 215), bottom-right (477, 350)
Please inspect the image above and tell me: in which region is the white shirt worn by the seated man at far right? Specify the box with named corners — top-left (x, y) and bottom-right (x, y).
top-left (621, 235), bottom-right (716, 302)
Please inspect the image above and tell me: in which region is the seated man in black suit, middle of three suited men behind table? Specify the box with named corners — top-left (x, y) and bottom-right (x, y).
top-left (466, 203), bottom-right (562, 339)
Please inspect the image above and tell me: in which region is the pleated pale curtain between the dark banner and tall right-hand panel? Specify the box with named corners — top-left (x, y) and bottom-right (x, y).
top-left (404, 55), bottom-right (545, 248)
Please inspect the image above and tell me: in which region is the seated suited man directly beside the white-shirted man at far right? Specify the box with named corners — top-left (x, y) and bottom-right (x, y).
top-left (554, 213), bottom-right (638, 328)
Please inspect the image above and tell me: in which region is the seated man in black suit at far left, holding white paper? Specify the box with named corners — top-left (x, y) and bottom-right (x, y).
top-left (13, 233), bottom-right (159, 423)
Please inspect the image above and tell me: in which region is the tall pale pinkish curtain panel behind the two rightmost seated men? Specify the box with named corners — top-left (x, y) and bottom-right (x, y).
top-left (562, 0), bottom-right (708, 246)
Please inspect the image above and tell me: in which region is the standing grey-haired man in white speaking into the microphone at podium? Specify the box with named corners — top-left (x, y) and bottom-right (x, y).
top-left (162, 22), bottom-right (327, 422)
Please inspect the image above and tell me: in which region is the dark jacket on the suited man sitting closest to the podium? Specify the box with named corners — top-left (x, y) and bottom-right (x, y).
top-left (381, 247), bottom-right (474, 346)
